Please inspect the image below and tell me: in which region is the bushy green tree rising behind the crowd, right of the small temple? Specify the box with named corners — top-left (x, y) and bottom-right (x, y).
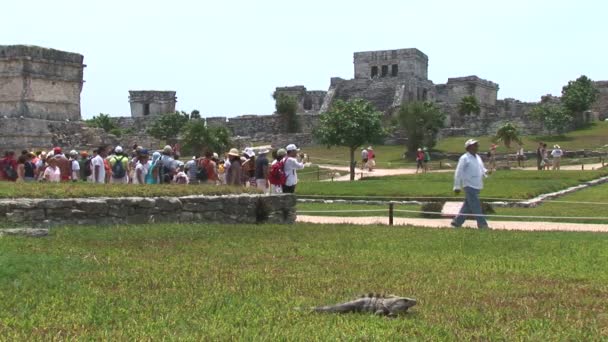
top-left (182, 119), bottom-right (230, 154)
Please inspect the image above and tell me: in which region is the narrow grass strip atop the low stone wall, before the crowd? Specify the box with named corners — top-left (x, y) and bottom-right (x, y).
top-left (0, 182), bottom-right (258, 198)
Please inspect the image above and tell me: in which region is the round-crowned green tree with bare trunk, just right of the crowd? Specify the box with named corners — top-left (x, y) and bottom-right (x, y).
top-left (315, 99), bottom-right (385, 181)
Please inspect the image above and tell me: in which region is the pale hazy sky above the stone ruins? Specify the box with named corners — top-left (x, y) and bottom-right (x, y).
top-left (0, 0), bottom-right (608, 118)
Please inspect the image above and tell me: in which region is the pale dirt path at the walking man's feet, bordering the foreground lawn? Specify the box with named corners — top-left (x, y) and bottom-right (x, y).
top-left (296, 215), bottom-right (608, 233)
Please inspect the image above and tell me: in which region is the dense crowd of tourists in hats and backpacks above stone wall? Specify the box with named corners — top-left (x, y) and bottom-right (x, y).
top-left (0, 144), bottom-right (305, 193)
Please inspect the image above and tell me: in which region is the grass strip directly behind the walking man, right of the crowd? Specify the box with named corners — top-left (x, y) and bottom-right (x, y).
top-left (297, 170), bottom-right (608, 199)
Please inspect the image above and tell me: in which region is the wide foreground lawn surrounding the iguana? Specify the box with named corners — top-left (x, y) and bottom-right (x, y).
top-left (0, 225), bottom-right (608, 341)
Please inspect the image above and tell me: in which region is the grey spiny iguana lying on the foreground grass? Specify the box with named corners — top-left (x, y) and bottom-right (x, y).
top-left (312, 293), bottom-right (416, 317)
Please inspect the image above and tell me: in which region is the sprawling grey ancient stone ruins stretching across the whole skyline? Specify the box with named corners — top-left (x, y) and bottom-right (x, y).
top-left (0, 45), bottom-right (608, 149)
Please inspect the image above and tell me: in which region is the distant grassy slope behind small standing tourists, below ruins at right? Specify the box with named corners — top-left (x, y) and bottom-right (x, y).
top-left (435, 122), bottom-right (608, 153)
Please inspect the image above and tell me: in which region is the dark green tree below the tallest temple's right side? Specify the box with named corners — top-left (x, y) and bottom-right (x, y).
top-left (397, 102), bottom-right (445, 156)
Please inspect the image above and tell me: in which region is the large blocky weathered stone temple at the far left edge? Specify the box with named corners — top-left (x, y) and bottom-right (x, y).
top-left (0, 45), bottom-right (85, 120)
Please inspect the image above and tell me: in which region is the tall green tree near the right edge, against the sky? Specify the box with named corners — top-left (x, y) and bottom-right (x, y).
top-left (561, 75), bottom-right (599, 128)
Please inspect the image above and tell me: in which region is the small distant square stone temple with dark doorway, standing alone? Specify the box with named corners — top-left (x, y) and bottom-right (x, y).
top-left (129, 90), bottom-right (177, 118)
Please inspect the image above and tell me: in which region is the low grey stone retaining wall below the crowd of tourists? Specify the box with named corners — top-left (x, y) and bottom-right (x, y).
top-left (0, 194), bottom-right (296, 227)
